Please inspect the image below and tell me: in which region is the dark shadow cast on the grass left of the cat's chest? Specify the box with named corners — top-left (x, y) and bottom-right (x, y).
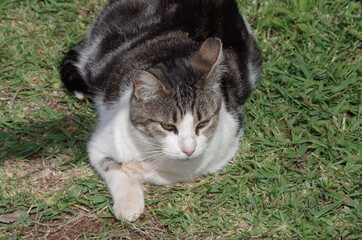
top-left (0, 114), bottom-right (93, 165)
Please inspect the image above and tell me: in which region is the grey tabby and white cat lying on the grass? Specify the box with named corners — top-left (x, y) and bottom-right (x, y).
top-left (60, 0), bottom-right (262, 221)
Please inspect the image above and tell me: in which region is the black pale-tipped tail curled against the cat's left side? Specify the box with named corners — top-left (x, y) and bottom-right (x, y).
top-left (60, 47), bottom-right (92, 100)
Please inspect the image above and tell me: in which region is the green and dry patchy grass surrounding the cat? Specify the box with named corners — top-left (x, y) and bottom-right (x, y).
top-left (0, 0), bottom-right (362, 239)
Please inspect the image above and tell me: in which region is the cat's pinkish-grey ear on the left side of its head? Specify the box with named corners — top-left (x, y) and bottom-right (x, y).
top-left (133, 70), bottom-right (168, 100)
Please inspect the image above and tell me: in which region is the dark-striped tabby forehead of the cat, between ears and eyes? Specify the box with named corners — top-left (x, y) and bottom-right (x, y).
top-left (135, 59), bottom-right (221, 123)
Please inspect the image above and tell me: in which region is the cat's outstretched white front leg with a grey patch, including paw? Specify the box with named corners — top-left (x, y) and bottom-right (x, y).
top-left (89, 149), bottom-right (145, 222)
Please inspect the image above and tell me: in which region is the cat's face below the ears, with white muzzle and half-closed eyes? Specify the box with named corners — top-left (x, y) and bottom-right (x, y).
top-left (131, 80), bottom-right (221, 159)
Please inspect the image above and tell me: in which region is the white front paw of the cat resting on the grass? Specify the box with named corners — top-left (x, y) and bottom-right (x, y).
top-left (113, 184), bottom-right (145, 222)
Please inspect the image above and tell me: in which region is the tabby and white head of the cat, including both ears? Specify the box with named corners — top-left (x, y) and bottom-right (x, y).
top-left (130, 38), bottom-right (225, 160)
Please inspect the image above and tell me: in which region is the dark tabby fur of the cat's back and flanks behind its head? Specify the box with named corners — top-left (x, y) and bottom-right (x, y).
top-left (62, 0), bottom-right (261, 110)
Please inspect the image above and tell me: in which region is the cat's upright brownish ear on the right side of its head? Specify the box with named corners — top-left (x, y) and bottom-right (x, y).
top-left (190, 38), bottom-right (223, 73)
